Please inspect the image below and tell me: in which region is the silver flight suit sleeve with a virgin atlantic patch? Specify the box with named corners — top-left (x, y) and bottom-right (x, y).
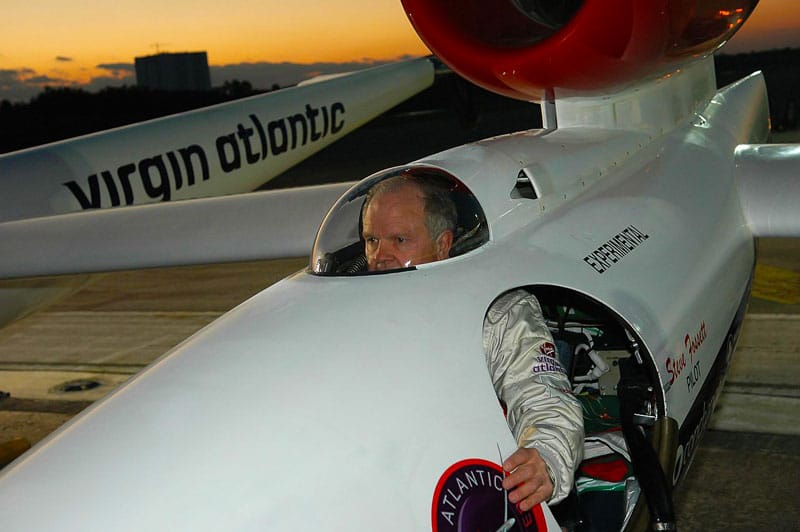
top-left (483, 290), bottom-right (583, 503)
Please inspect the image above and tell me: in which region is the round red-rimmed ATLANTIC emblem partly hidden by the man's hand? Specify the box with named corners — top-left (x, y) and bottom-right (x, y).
top-left (431, 458), bottom-right (547, 532)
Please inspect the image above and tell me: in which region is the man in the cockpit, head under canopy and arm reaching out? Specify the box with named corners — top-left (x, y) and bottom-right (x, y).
top-left (361, 175), bottom-right (583, 511)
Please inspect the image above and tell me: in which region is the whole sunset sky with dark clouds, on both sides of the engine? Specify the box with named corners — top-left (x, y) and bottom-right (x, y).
top-left (0, 0), bottom-right (800, 101)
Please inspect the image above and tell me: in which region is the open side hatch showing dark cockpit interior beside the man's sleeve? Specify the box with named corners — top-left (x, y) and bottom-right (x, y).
top-left (531, 286), bottom-right (677, 530)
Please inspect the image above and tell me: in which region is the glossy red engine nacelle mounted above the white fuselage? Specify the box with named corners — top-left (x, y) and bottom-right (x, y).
top-left (402, 0), bottom-right (758, 100)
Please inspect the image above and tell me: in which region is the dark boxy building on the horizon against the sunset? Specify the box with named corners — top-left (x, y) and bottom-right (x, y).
top-left (136, 52), bottom-right (211, 91)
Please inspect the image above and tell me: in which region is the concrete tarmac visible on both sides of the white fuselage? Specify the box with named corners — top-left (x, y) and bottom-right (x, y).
top-left (0, 110), bottom-right (800, 531)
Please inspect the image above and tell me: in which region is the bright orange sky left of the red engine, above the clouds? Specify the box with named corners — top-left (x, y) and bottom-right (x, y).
top-left (0, 0), bottom-right (427, 85)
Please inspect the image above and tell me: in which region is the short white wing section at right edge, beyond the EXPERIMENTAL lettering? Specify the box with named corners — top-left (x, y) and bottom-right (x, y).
top-left (736, 144), bottom-right (800, 237)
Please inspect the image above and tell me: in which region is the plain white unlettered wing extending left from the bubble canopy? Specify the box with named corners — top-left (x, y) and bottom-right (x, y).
top-left (0, 183), bottom-right (353, 279)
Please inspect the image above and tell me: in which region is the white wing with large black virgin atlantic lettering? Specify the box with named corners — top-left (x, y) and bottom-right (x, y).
top-left (0, 58), bottom-right (434, 221)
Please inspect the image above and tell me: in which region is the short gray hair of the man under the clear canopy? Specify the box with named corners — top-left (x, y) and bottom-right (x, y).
top-left (361, 174), bottom-right (458, 239)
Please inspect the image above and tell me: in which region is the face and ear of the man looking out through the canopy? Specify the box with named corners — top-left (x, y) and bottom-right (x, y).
top-left (363, 185), bottom-right (453, 271)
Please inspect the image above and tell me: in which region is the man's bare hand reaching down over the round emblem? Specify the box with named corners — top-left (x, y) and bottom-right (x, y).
top-left (503, 447), bottom-right (553, 512)
